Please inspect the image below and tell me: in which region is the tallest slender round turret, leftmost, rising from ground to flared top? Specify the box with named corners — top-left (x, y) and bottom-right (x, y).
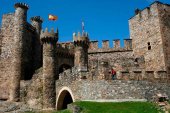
top-left (9, 3), bottom-right (28, 101)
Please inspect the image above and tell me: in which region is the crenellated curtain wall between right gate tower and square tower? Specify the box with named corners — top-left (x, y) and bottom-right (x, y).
top-left (88, 39), bottom-right (135, 71)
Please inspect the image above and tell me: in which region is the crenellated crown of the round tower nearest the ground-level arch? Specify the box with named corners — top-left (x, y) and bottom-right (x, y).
top-left (40, 28), bottom-right (58, 43)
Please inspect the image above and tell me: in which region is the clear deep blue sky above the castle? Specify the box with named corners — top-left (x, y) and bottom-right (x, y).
top-left (0, 0), bottom-right (170, 46)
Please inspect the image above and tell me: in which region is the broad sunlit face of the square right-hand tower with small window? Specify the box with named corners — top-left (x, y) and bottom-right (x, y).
top-left (129, 2), bottom-right (166, 71)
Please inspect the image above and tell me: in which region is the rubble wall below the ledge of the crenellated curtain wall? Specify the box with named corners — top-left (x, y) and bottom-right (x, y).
top-left (88, 51), bottom-right (139, 71)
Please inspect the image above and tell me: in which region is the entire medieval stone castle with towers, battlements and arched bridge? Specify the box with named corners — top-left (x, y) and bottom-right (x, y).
top-left (0, 2), bottom-right (170, 110)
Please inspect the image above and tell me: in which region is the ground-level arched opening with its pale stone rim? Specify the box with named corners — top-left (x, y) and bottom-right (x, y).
top-left (56, 87), bottom-right (74, 110)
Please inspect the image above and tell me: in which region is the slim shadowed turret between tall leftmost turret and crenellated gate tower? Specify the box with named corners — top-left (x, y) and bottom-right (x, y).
top-left (31, 16), bottom-right (43, 70)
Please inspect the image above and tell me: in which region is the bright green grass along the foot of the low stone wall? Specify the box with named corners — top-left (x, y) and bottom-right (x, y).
top-left (26, 102), bottom-right (163, 113)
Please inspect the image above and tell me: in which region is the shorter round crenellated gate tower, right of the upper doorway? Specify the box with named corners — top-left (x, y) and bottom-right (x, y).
top-left (73, 32), bottom-right (89, 71)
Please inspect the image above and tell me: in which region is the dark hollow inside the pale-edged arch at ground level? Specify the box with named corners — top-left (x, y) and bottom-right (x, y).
top-left (57, 90), bottom-right (73, 110)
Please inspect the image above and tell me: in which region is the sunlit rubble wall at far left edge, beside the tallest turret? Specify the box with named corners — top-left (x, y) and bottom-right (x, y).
top-left (0, 14), bottom-right (15, 99)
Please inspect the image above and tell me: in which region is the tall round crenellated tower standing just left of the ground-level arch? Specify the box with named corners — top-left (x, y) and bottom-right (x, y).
top-left (41, 29), bottom-right (58, 109)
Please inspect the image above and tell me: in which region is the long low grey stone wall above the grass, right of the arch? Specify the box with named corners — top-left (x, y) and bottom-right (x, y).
top-left (56, 80), bottom-right (170, 101)
